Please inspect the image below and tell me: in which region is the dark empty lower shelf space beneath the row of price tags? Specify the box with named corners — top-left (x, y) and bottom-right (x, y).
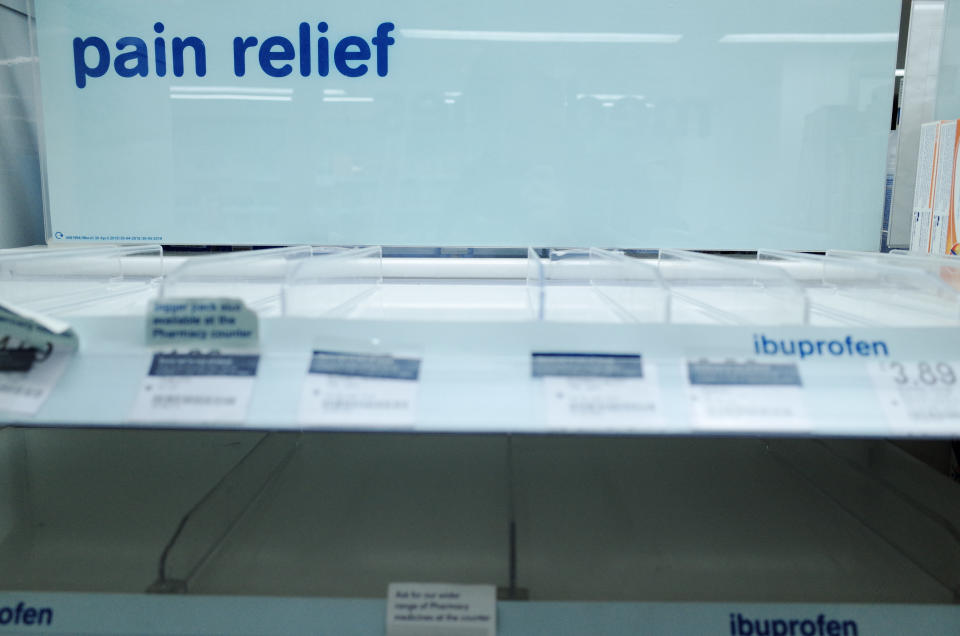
top-left (0, 428), bottom-right (960, 604)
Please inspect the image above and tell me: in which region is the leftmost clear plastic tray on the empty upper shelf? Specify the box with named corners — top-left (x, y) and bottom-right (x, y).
top-left (0, 245), bottom-right (164, 316)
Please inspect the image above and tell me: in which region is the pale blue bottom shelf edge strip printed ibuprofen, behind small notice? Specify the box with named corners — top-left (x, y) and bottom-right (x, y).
top-left (0, 592), bottom-right (960, 636)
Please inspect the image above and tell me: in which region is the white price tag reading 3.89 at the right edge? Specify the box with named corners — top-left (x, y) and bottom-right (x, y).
top-left (867, 360), bottom-right (960, 433)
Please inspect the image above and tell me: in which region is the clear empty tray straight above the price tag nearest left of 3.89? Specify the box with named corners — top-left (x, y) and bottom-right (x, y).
top-left (659, 249), bottom-right (809, 325)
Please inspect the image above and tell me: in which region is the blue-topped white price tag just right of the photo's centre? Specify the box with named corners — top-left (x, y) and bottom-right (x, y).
top-left (531, 353), bottom-right (662, 431)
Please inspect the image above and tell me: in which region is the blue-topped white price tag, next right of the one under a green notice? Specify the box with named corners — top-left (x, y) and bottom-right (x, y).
top-left (299, 351), bottom-right (420, 427)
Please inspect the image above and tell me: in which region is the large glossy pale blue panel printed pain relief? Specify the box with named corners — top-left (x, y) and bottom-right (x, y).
top-left (31, 0), bottom-right (900, 249)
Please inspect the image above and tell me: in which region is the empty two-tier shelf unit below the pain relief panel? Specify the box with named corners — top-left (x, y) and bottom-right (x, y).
top-left (0, 247), bottom-right (960, 634)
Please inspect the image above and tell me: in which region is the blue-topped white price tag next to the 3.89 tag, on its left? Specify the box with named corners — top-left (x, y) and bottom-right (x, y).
top-left (686, 360), bottom-right (810, 431)
